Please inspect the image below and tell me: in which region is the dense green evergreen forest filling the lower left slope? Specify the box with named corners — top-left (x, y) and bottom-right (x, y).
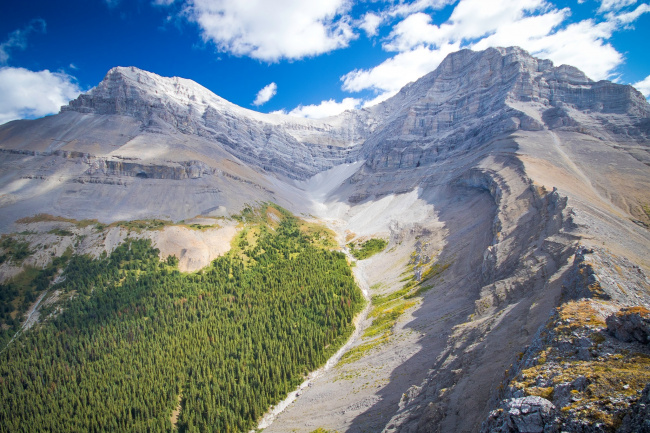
top-left (0, 206), bottom-right (364, 432)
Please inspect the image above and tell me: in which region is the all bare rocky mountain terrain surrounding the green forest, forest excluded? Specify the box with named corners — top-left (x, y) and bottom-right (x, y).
top-left (0, 47), bottom-right (650, 432)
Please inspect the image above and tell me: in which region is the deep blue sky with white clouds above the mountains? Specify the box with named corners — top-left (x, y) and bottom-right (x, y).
top-left (0, 0), bottom-right (650, 123)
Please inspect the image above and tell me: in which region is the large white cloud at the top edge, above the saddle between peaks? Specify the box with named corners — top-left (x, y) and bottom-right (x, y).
top-left (186, 0), bottom-right (357, 61)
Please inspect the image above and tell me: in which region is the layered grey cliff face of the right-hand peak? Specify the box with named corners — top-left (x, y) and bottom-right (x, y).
top-left (354, 48), bottom-right (650, 177)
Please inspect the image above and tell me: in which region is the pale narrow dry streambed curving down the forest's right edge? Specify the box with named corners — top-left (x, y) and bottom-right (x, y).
top-left (254, 248), bottom-right (371, 433)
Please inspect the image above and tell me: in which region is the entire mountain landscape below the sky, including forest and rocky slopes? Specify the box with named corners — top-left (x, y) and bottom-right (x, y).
top-left (0, 47), bottom-right (650, 433)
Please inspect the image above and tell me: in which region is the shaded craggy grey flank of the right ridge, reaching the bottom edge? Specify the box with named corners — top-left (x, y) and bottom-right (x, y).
top-left (347, 140), bottom-right (575, 433)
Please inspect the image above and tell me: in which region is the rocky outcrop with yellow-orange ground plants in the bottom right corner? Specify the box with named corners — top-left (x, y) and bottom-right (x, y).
top-left (482, 286), bottom-right (650, 433)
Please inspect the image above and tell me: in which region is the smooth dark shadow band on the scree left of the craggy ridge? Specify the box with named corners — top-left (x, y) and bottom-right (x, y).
top-left (347, 183), bottom-right (496, 433)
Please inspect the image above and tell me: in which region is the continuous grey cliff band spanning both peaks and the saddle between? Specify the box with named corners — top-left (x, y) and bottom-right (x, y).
top-left (55, 48), bottom-right (650, 178)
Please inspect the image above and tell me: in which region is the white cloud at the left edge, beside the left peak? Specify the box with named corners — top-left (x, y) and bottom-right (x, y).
top-left (0, 67), bottom-right (81, 124)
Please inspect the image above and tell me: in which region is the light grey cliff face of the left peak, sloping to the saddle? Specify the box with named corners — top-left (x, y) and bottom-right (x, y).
top-left (62, 67), bottom-right (363, 178)
